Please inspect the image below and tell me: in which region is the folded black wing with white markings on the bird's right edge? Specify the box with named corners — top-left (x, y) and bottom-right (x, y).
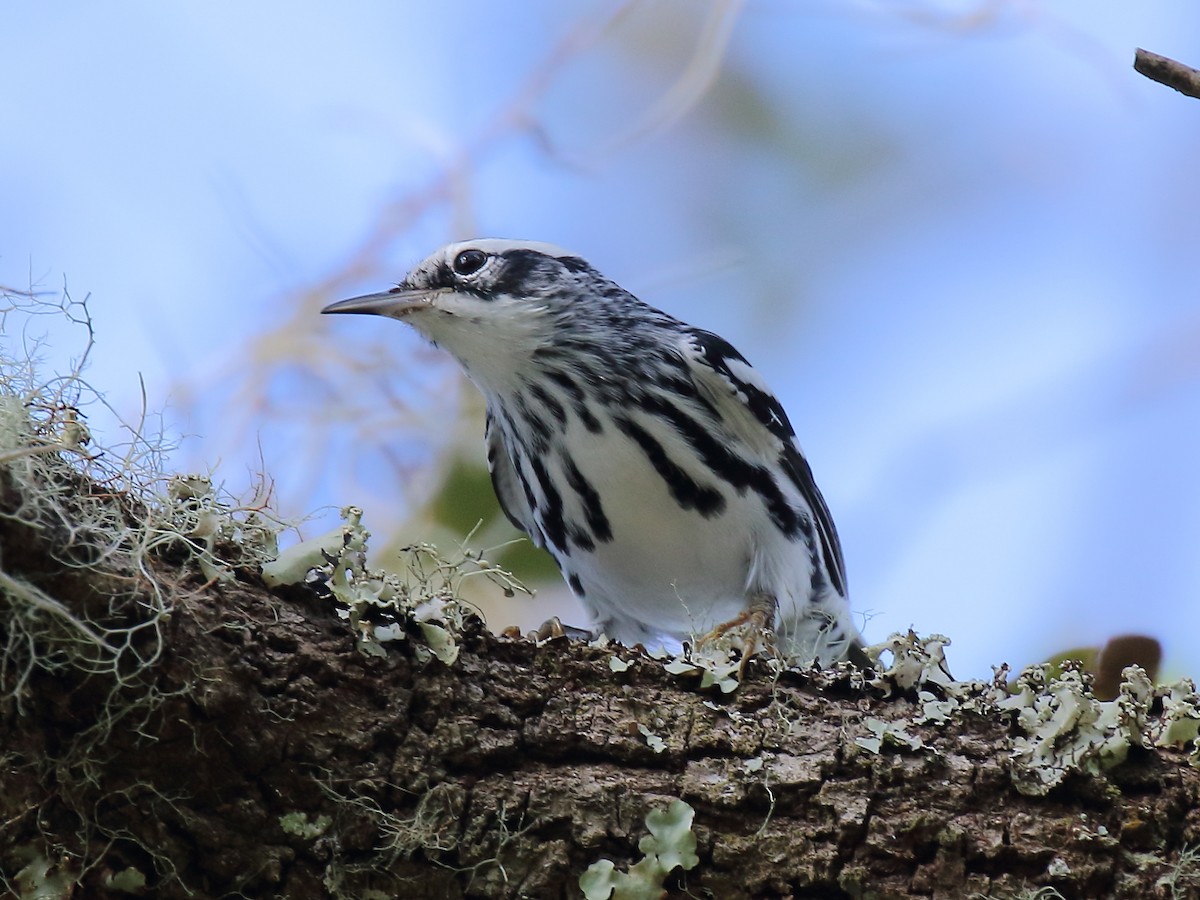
top-left (683, 329), bottom-right (846, 596)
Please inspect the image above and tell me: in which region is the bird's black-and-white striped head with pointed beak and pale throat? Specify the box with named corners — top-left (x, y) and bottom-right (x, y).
top-left (322, 239), bottom-right (619, 391)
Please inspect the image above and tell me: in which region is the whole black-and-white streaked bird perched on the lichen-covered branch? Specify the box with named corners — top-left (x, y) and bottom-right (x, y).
top-left (322, 239), bottom-right (868, 665)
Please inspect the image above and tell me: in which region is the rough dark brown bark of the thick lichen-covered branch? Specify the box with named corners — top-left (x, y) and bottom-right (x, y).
top-left (0, 468), bottom-right (1200, 899)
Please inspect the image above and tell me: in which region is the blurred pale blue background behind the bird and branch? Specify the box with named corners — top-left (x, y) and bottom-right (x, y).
top-left (0, 0), bottom-right (1200, 677)
